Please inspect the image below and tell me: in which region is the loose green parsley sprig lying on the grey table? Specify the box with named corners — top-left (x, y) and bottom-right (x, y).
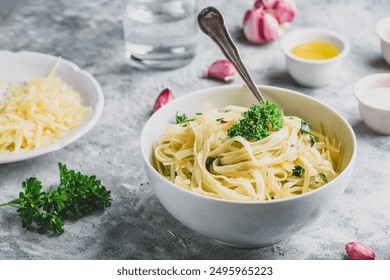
top-left (0, 163), bottom-right (111, 234)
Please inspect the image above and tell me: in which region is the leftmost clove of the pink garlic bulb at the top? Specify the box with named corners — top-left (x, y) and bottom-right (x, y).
top-left (244, 9), bottom-right (265, 44)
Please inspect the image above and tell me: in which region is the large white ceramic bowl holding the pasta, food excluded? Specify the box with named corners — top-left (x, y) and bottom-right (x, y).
top-left (141, 85), bottom-right (356, 248)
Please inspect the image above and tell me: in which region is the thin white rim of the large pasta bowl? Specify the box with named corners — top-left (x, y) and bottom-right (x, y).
top-left (140, 85), bottom-right (357, 205)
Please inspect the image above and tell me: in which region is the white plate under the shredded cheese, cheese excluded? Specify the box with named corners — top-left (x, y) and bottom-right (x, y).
top-left (0, 51), bottom-right (104, 164)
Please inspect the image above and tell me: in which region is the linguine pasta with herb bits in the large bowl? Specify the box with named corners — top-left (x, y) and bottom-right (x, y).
top-left (154, 105), bottom-right (341, 201)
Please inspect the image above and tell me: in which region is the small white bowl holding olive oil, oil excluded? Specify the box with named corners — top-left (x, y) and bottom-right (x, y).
top-left (280, 28), bottom-right (349, 87)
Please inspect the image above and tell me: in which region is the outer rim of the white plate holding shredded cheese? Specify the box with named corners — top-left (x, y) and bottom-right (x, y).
top-left (0, 50), bottom-right (104, 164)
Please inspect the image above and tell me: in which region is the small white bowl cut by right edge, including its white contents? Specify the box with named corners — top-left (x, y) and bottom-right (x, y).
top-left (354, 73), bottom-right (390, 135)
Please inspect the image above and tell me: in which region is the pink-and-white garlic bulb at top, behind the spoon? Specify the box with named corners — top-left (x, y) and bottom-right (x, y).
top-left (243, 0), bottom-right (297, 44)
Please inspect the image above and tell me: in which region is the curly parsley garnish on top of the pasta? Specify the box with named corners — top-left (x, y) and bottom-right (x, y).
top-left (227, 100), bottom-right (283, 141)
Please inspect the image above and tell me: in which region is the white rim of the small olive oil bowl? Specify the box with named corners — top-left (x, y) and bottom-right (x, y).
top-left (279, 27), bottom-right (350, 65)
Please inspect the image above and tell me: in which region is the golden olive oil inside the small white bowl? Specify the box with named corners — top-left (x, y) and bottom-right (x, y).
top-left (291, 41), bottom-right (340, 60)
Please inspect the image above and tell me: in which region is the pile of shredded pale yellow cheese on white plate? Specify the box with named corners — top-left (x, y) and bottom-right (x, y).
top-left (0, 75), bottom-right (90, 153)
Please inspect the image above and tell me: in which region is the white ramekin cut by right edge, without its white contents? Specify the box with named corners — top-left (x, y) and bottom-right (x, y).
top-left (354, 73), bottom-right (390, 135)
